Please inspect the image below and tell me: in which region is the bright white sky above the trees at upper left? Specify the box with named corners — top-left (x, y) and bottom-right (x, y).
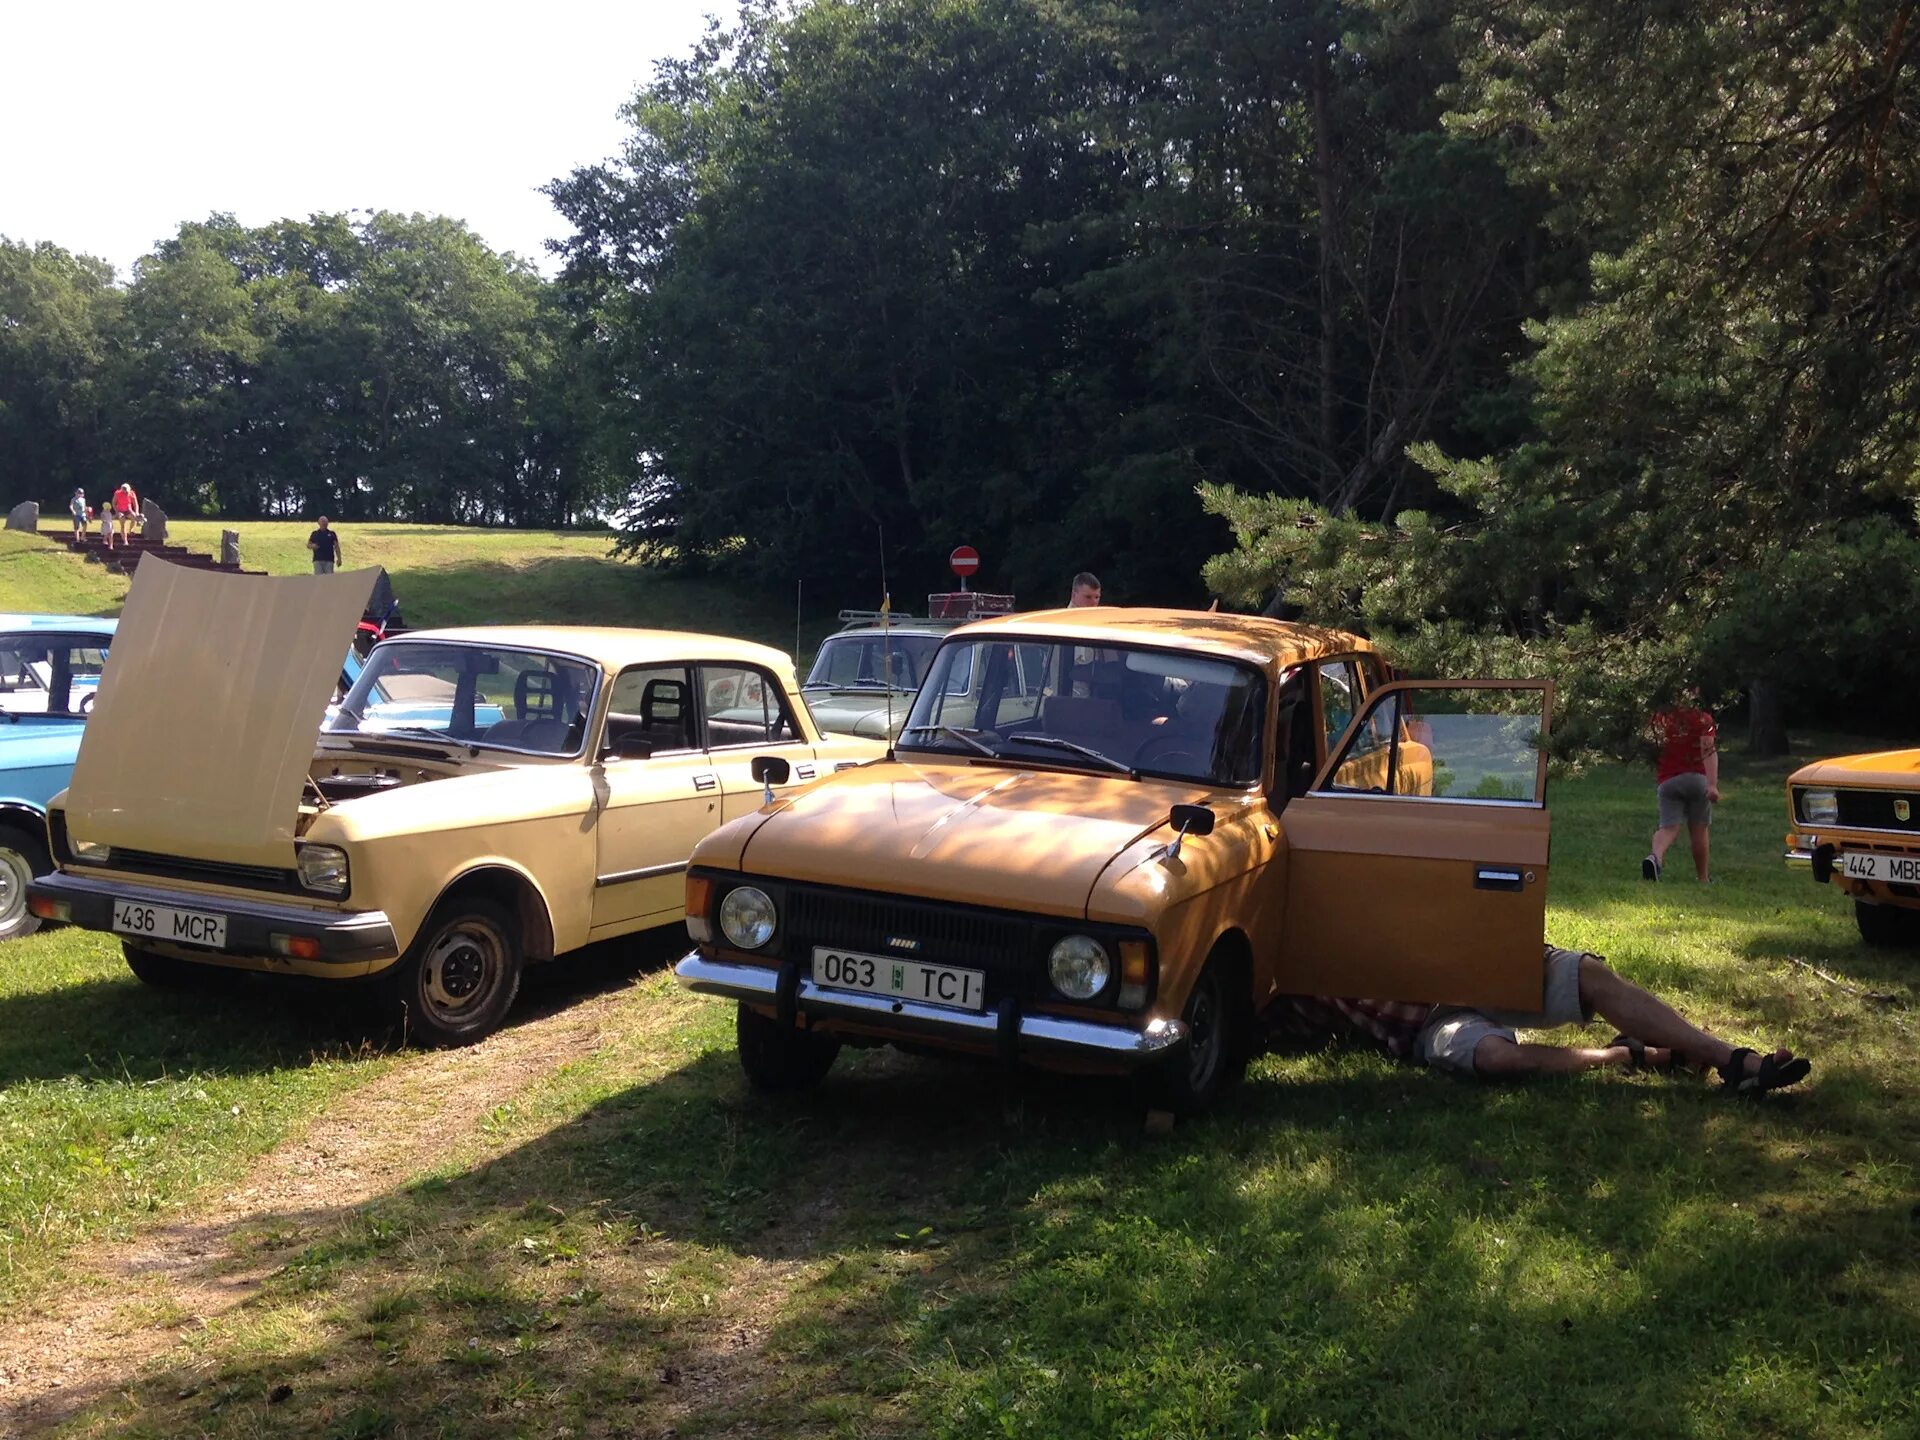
top-left (0, 0), bottom-right (733, 280)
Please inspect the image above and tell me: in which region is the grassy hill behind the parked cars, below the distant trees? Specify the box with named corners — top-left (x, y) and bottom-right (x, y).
top-left (0, 520), bottom-right (817, 649)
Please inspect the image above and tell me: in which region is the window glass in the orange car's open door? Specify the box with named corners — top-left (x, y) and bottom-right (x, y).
top-left (1327, 685), bottom-right (1542, 804)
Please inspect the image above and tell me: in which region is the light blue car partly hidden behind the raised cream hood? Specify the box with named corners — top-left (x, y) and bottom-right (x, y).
top-left (0, 614), bottom-right (113, 941)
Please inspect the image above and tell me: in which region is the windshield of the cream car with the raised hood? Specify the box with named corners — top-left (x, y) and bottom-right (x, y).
top-left (324, 639), bottom-right (599, 755)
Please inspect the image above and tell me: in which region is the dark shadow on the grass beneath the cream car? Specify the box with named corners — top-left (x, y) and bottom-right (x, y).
top-left (0, 927), bottom-right (685, 1089)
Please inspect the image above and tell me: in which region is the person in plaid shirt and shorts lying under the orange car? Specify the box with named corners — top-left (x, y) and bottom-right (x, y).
top-left (1279, 945), bottom-right (1812, 1091)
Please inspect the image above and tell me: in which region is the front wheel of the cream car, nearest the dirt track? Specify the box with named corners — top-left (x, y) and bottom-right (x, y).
top-left (380, 895), bottom-right (524, 1050)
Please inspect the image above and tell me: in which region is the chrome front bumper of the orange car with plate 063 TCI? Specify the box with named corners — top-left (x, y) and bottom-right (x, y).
top-left (674, 950), bottom-right (1187, 1066)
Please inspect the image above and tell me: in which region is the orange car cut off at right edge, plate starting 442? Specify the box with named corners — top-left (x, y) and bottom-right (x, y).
top-left (1788, 751), bottom-right (1920, 945)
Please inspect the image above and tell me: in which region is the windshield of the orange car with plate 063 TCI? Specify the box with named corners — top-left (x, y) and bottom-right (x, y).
top-left (900, 637), bottom-right (1267, 785)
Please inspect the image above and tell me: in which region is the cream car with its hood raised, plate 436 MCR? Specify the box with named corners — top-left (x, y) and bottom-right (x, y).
top-left (31, 561), bottom-right (881, 1044)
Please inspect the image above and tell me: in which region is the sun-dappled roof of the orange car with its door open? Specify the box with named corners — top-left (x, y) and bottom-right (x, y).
top-left (948, 605), bottom-right (1373, 668)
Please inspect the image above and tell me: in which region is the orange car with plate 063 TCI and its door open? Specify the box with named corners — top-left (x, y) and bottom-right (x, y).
top-left (676, 609), bottom-right (1549, 1110)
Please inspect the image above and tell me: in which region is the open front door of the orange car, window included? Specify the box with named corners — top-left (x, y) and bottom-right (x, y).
top-left (1275, 680), bottom-right (1553, 1010)
